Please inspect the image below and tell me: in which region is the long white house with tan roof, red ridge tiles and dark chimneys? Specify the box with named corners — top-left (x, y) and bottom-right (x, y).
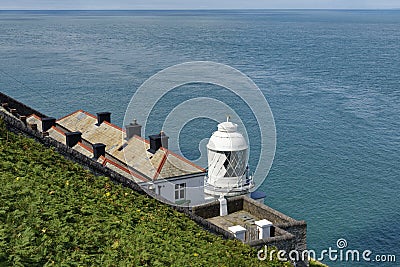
top-left (27, 110), bottom-right (205, 205)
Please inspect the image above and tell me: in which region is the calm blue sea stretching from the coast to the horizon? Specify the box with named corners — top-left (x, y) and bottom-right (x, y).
top-left (0, 11), bottom-right (400, 266)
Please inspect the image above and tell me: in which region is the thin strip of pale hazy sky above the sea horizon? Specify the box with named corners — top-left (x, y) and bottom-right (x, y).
top-left (0, 0), bottom-right (400, 9)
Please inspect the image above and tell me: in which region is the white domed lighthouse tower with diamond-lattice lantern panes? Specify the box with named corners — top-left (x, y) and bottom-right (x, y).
top-left (204, 117), bottom-right (254, 197)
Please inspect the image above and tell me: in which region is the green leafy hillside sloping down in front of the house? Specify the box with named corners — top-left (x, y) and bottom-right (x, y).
top-left (0, 122), bottom-right (288, 266)
